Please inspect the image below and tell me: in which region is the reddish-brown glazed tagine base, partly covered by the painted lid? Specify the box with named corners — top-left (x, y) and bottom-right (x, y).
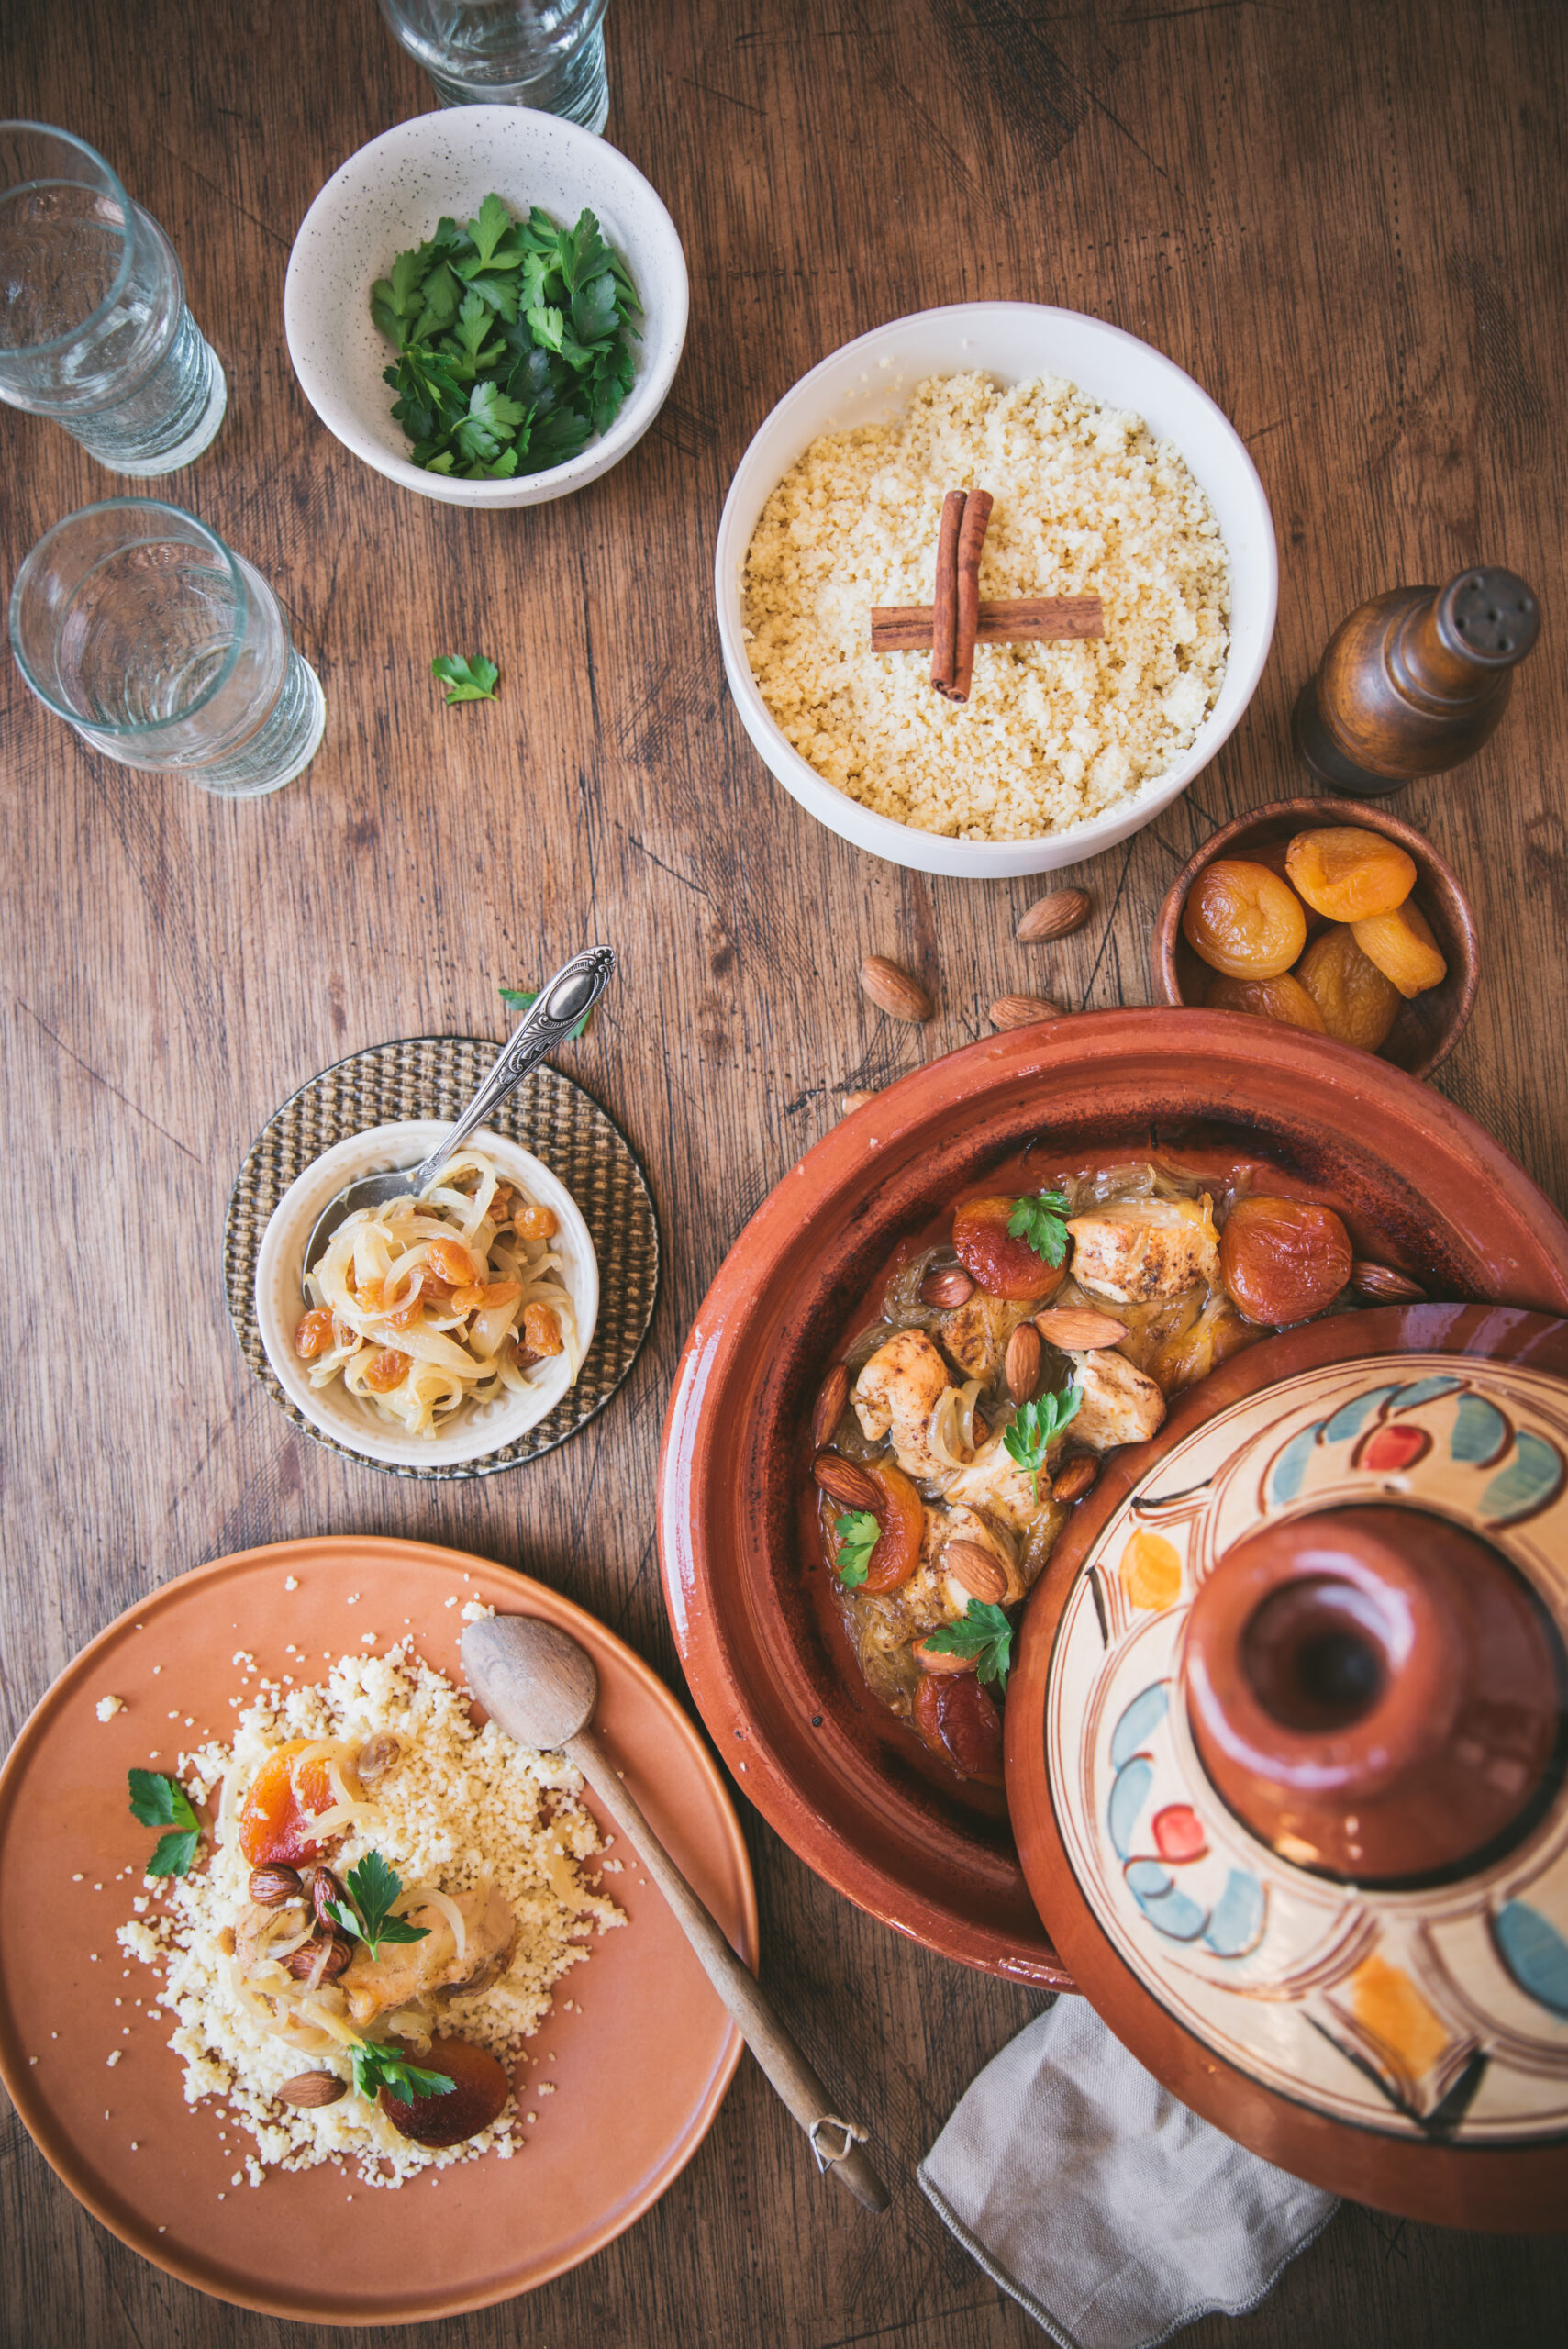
top-left (660, 1008), bottom-right (1568, 1985)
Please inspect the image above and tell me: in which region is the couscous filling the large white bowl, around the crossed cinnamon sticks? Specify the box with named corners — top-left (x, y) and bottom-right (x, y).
top-left (744, 373), bottom-right (1230, 841)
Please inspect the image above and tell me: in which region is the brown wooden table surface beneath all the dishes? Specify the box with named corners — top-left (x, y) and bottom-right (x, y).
top-left (0, 0), bottom-right (1568, 2349)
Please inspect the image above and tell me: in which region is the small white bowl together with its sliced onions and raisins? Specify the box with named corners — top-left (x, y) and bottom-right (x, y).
top-left (256, 1119), bottom-right (598, 1468)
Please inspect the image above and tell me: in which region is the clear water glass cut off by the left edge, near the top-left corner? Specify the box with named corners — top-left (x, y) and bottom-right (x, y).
top-left (0, 122), bottom-right (228, 474)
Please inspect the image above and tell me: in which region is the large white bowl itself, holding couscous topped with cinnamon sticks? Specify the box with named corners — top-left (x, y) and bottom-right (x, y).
top-left (714, 301), bottom-right (1279, 881)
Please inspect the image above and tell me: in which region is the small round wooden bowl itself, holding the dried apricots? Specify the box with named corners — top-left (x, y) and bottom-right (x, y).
top-left (1148, 798), bottom-right (1481, 1075)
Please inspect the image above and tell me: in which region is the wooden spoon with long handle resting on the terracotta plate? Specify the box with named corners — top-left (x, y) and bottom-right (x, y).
top-left (462, 1616), bottom-right (887, 2210)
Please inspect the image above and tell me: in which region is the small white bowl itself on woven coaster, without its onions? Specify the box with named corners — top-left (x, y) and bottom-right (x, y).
top-left (256, 1119), bottom-right (598, 1468)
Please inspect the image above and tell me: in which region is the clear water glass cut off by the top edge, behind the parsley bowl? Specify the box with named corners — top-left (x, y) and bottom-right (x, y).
top-left (380, 0), bottom-right (610, 131)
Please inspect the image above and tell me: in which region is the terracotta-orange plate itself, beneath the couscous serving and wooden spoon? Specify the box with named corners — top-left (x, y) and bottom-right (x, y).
top-left (0, 1536), bottom-right (756, 2325)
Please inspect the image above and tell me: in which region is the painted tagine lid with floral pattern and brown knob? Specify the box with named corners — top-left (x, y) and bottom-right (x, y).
top-left (1007, 1308), bottom-right (1568, 2227)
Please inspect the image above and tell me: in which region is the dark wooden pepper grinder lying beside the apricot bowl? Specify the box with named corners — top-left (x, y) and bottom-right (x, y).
top-left (1294, 566), bottom-right (1540, 798)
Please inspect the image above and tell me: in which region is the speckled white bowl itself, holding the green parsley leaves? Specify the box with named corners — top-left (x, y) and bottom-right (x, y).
top-left (284, 106), bottom-right (688, 507)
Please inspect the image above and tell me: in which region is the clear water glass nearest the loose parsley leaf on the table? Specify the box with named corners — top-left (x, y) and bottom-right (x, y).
top-left (12, 498), bottom-right (327, 798)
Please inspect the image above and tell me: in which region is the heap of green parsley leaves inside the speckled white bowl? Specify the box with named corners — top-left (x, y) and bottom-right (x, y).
top-left (371, 195), bottom-right (643, 482)
